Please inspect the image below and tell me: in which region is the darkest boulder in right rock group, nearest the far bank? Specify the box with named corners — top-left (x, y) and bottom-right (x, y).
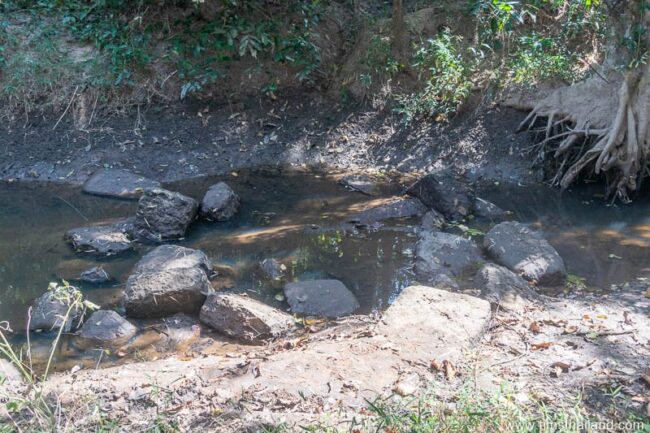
top-left (406, 172), bottom-right (474, 220)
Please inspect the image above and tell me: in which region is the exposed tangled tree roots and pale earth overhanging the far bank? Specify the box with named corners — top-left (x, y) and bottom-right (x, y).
top-left (509, 51), bottom-right (650, 200)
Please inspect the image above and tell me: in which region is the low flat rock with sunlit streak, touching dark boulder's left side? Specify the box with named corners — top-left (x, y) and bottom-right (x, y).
top-left (64, 219), bottom-right (133, 256)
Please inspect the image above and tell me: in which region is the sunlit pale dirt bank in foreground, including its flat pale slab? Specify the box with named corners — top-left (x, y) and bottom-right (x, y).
top-left (5, 283), bottom-right (650, 432)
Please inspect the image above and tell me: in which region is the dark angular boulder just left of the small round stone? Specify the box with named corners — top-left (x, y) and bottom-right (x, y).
top-left (133, 188), bottom-right (199, 242)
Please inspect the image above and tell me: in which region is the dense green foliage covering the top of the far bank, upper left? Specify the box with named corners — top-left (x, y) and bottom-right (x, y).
top-left (0, 0), bottom-right (321, 106)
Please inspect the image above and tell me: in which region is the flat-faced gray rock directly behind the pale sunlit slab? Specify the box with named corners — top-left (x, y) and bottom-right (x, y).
top-left (415, 231), bottom-right (483, 282)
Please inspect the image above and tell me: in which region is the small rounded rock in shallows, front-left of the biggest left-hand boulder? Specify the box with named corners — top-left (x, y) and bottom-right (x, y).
top-left (79, 310), bottom-right (138, 346)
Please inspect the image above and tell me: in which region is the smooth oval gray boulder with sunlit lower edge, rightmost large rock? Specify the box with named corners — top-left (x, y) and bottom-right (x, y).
top-left (483, 221), bottom-right (566, 285)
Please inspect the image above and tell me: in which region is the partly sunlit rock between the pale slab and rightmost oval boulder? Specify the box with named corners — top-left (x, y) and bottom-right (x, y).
top-left (474, 263), bottom-right (537, 311)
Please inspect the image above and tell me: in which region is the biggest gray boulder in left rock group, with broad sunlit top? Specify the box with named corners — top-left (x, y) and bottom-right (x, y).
top-left (124, 245), bottom-right (212, 317)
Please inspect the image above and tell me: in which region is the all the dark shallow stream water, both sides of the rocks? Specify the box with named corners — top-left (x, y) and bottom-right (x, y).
top-left (0, 172), bottom-right (650, 368)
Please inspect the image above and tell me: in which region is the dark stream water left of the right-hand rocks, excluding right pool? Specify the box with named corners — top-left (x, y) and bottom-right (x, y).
top-left (0, 173), bottom-right (415, 330)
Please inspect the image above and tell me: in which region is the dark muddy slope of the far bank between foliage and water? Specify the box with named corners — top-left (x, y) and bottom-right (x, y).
top-left (0, 93), bottom-right (539, 183)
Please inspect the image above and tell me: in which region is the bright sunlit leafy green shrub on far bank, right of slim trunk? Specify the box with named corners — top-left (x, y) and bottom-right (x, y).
top-left (396, 31), bottom-right (472, 122)
